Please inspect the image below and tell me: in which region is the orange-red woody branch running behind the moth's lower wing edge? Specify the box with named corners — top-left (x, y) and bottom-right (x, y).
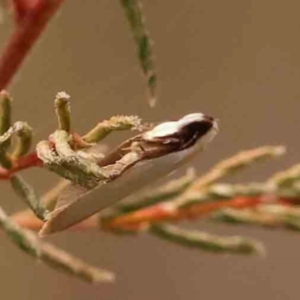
top-left (12, 197), bottom-right (298, 231)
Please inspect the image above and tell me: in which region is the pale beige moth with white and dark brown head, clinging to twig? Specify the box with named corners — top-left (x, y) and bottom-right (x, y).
top-left (39, 113), bottom-right (218, 236)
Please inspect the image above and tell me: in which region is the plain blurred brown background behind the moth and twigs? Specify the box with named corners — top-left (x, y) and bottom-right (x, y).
top-left (0, 0), bottom-right (300, 300)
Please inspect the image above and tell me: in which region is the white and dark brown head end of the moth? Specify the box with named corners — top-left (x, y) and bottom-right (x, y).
top-left (143, 113), bottom-right (218, 150)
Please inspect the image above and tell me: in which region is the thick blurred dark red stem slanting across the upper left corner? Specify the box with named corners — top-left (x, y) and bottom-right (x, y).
top-left (0, 0), bottom-right (63, 90)
